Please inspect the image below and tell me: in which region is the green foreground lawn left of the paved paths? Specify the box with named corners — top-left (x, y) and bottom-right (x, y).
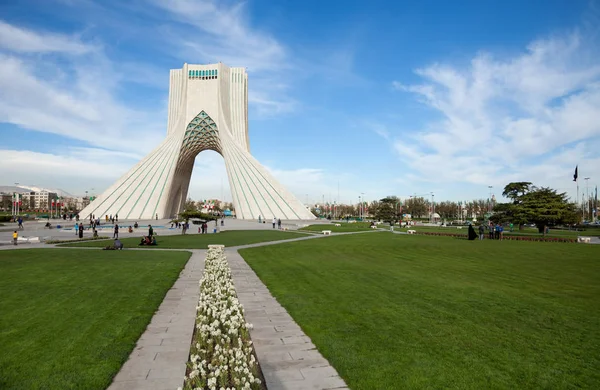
top-left (0, 249), bottom-right (190, 390)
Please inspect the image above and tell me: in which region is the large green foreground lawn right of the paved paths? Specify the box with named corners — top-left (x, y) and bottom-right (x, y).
top-left (240, 233), bottom-right (600, 390)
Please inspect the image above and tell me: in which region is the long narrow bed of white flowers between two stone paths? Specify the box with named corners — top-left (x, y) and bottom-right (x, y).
top-left (183, 245), bottom-right (264, 390)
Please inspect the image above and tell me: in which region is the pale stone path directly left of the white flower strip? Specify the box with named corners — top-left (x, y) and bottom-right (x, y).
top-left (108, 250), bottom-right (206, 390)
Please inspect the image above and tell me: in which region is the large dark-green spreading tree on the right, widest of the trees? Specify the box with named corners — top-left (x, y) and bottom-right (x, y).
top-left (493, 182), bottom-right (578, 234)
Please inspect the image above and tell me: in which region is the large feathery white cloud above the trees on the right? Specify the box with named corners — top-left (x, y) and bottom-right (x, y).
top-left (392, 33), bottom-right (600, 200)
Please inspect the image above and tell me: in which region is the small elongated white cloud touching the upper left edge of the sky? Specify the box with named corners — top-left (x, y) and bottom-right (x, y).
top-left (0, 20), bottom-right (95, 54)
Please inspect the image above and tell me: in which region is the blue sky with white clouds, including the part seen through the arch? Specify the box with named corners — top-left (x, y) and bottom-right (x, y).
top-left (0, 0), bottom-right (600, 206)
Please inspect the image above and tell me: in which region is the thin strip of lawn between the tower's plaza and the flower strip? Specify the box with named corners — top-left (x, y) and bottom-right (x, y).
top-left (62, 230), bottom-right (306, 249)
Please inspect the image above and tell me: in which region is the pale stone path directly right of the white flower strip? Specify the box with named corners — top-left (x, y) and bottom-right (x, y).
top-left (225, 250), bottom-right (347, 390)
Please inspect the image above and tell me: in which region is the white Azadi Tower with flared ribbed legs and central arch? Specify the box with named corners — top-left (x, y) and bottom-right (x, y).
top-left (79, 63), bottom-right (315, 219)
